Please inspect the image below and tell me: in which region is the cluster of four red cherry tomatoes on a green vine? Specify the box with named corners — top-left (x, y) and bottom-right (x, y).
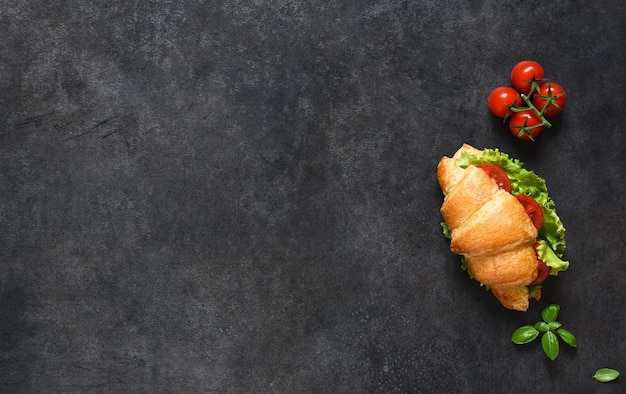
top-left (488, 60), bottom-right (567, 141)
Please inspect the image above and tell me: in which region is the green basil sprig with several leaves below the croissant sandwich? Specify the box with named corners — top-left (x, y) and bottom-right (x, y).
top-left (511, 304), bottom-right (577, 361)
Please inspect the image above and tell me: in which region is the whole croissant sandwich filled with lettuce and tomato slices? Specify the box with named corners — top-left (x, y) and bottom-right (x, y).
top-left (437, 144), bottom-right (569, 311)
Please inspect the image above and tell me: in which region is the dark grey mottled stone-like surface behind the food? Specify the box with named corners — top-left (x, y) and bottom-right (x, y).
top-left (0, 0), bottom-right (626, 393)
